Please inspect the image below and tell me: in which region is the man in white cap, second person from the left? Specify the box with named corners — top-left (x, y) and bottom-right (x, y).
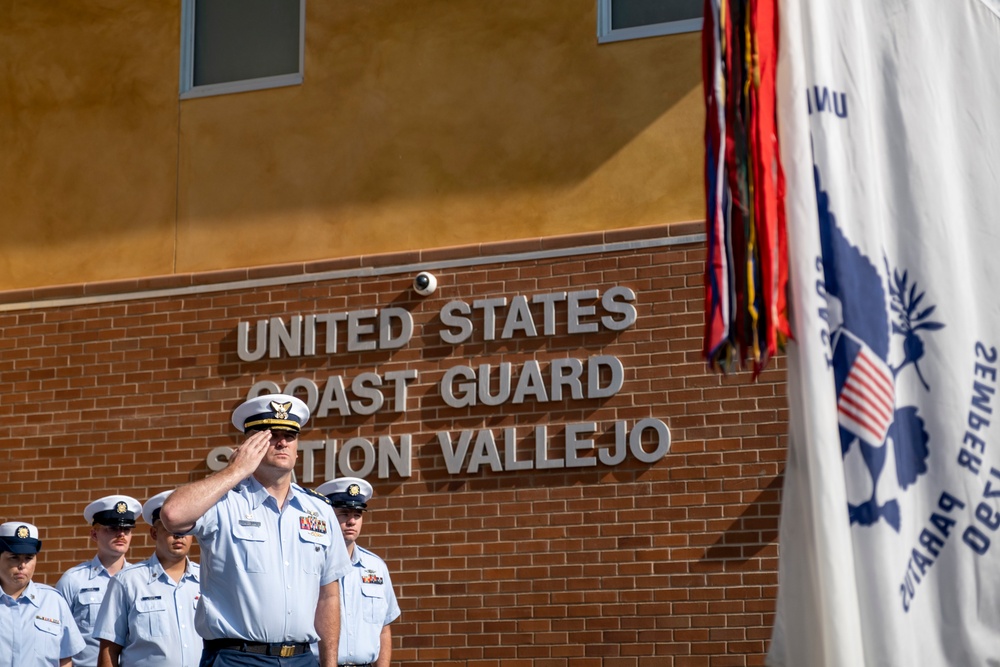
top-left (56, 495), bottom-right (142, 667)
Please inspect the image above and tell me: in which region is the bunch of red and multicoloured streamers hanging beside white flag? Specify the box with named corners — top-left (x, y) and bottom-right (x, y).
top-left (702, 0), bottom-right (791, 377)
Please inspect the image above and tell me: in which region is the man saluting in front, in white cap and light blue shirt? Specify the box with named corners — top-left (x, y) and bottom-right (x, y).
top-left (160, 394), bottom-right (351, 667)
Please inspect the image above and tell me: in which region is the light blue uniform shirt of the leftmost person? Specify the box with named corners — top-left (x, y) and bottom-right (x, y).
top-left (0, 581), bottom-right (86, 667)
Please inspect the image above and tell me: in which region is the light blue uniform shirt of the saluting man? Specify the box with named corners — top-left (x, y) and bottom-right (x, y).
top-left (192, 477), bottom-right (351, 643)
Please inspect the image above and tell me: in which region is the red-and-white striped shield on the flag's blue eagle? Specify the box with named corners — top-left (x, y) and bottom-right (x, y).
top-left (837, 340), bottom-right (896, 445)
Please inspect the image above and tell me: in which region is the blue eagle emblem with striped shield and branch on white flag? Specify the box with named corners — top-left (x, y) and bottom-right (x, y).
top-left (815, 168), bottom-right (944, 532)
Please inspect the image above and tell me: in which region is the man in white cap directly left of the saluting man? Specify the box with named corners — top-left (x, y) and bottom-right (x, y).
top-left (94, 491), bottom-right (202, 667)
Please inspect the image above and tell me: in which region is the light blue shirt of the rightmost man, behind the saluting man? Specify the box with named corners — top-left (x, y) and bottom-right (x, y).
top-left (337, 544), bottom-right (400, 665)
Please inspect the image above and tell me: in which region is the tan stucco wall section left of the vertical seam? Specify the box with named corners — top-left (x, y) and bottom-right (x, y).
top-left (0, 0), bottom-right (180, 288)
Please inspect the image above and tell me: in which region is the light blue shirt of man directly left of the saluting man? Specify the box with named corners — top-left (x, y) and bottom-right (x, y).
top-left (94, 554), bottom-right (202, 667)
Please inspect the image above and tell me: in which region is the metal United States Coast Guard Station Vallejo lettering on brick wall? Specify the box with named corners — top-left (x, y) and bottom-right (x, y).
top-left (207, 286), bottom-right (670, 483)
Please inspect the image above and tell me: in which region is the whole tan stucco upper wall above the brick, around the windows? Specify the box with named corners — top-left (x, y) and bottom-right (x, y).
top-left (0, 0), bottom-right (703, 289)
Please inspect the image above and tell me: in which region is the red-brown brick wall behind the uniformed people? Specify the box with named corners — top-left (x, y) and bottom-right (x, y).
top-left (0, 225), bottom-right (787, 667)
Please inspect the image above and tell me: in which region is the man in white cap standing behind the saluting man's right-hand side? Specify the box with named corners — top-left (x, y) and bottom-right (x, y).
top-left (316, 477), bottom-right (400, 667)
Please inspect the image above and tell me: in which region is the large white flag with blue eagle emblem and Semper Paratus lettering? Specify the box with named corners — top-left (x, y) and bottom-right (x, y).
top-left (768, 0), bottom-right (1000, 667)
